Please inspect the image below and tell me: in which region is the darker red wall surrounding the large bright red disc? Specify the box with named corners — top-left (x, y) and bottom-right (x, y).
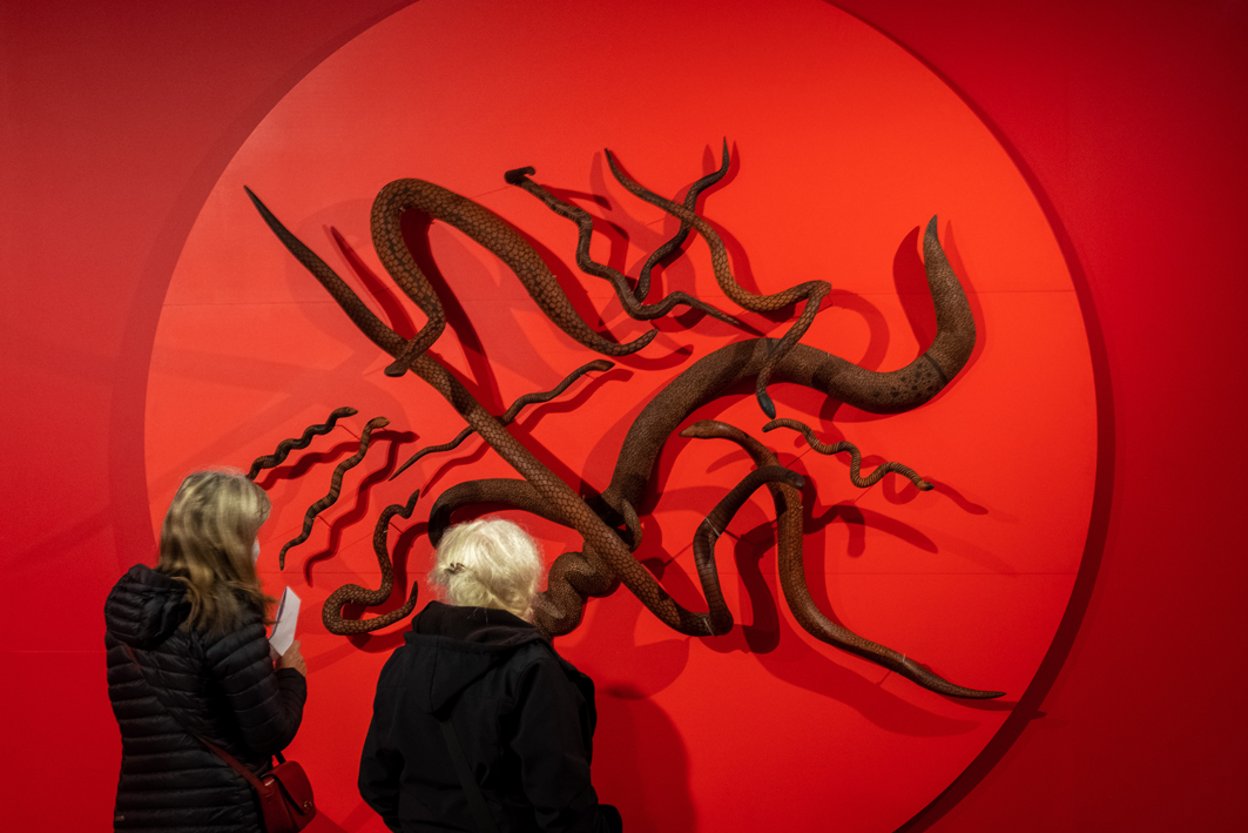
top-left (0, 0), bottom-right (1248, 831)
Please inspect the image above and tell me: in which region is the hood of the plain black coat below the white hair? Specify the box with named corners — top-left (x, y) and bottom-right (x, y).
top-left (401, 602), bottom-right (549, 714)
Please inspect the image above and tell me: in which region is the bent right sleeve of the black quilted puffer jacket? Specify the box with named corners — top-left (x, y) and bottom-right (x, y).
top-left (206, 616), bottom-right (307, 757)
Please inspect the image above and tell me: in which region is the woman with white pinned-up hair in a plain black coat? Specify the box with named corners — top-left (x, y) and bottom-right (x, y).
top-left (359, 518), bottom-right (622, 833)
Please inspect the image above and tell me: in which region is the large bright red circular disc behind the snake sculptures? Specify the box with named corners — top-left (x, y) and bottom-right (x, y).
top-left (147, 0), bottom-right (1096, 831)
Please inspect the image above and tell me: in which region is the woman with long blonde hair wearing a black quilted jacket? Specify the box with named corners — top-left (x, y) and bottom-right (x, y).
top-left (105, 471), bottom-right (307, 833)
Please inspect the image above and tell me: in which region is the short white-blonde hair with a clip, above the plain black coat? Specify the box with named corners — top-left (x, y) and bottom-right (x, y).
top-left (429, 518), bottom-right (543, 619)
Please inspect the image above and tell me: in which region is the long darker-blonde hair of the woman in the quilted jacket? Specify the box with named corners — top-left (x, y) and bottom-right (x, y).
top-left (156, 470), bottom-right (272, 633)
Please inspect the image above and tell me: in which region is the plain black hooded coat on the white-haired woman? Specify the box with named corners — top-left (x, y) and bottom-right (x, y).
top-left (359, 602), bottom-right (619, 833)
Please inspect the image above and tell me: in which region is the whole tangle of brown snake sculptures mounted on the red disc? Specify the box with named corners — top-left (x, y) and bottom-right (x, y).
top-left (240, 141), bottom-right (1003, 699)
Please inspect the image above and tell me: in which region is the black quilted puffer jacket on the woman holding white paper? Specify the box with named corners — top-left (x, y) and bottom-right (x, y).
top-left (105, 564), bottom-right (307, 833)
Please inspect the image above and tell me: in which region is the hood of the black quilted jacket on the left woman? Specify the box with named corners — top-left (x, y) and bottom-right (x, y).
top-left (104, 564), bottom-right (191, 648)
